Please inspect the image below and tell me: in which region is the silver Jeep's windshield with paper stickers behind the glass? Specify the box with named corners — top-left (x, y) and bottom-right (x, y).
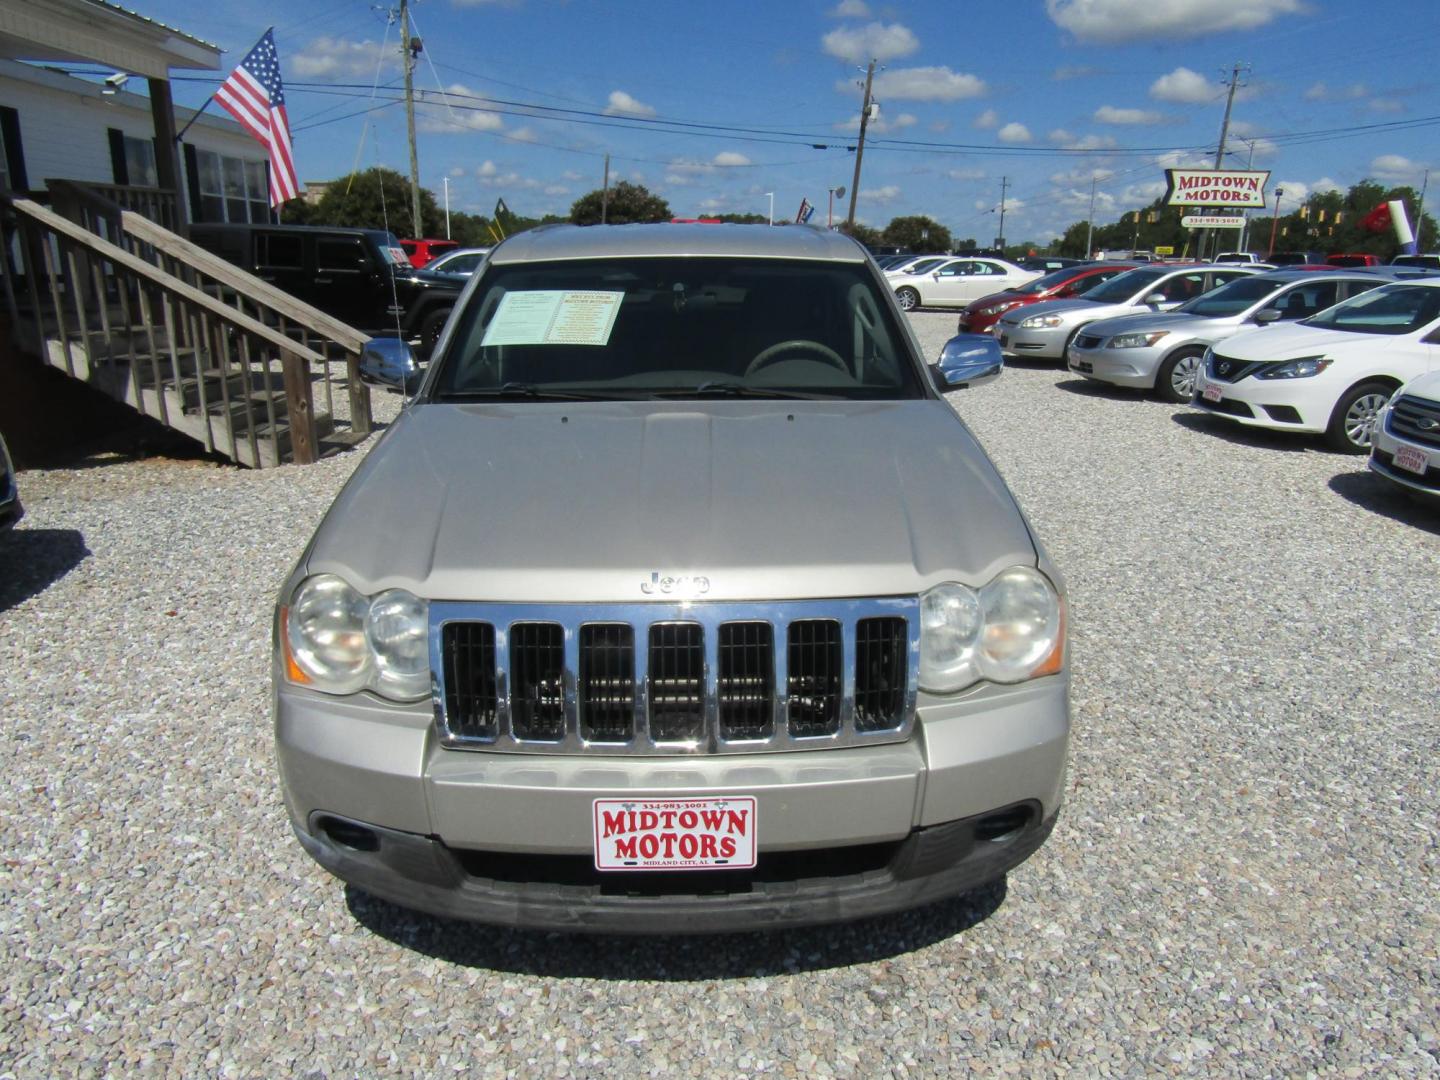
top-left (433, 258), bottom-right (924, 400)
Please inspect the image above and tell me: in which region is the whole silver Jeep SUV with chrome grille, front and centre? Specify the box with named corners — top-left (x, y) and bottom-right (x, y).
top-left (274, 225), bottom-right (1070, 933)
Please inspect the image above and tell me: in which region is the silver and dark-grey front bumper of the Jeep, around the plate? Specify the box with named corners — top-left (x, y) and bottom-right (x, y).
top-left (275, 675), bottom-right (1070, 933)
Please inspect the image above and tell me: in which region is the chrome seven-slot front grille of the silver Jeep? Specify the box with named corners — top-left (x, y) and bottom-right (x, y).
top-left (431, 598), bottom-right (920, 755)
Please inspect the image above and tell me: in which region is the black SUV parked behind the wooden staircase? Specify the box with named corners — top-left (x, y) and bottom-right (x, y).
top-left (190, 225), bottom-right (465, 354)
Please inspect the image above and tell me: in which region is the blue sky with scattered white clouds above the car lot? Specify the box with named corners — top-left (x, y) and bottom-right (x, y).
top-left (120, 0), bottom-right (1440, 240)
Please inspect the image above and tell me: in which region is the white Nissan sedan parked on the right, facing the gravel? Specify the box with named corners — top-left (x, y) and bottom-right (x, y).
top-left (1192, 278), bottom-right (1440, 454)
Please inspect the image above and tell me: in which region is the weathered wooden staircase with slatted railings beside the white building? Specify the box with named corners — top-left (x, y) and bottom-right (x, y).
top-left (0, 181), bottom-right (373, 468)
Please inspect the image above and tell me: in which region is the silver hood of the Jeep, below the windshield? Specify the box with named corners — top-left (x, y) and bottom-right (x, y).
top-left (304, 399), bottom-right (1037, 602)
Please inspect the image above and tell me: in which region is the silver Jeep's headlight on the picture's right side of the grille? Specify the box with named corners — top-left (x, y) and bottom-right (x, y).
top-left (920, 566), bottom-right (1064, 694)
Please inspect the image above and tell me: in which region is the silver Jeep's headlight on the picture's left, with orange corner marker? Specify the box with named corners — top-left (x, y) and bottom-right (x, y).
top-left (281, 573), bottom-right (431, 701)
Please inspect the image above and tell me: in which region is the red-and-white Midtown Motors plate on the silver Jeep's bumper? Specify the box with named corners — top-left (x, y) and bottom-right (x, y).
top-left (593, 795), bottom-right (756, 870)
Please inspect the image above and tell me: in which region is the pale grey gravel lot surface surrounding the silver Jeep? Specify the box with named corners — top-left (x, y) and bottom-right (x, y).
top-left (0, 314), bottom-right (1440, 1077)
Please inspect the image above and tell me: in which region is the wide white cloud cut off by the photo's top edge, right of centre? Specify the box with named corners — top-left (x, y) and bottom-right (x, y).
top-left (1045, 0), bottom-right (1305, 43)
